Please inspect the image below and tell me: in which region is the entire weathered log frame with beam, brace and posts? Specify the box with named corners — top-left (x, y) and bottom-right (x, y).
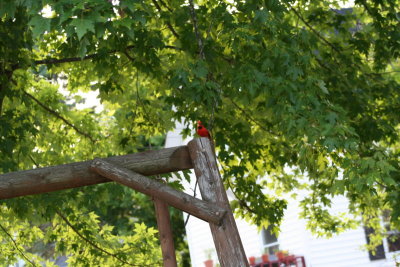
top-left (0, 138), bottom-right (249, 267)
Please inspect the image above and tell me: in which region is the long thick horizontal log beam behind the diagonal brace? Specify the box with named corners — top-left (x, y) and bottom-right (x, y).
top-left (0, 146), bottom-right (192, 199)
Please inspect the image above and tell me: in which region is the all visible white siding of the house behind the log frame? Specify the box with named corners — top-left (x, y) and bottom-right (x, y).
top-left (165, 125), bottom-right (395, 267)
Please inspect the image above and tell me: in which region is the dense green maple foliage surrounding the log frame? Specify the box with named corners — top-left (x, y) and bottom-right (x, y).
top-left (0, 0), bottom-right (400, 266)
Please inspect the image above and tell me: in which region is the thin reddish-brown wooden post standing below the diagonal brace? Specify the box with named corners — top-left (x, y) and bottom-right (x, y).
top-left (153, 198), bottom-right (177, 267)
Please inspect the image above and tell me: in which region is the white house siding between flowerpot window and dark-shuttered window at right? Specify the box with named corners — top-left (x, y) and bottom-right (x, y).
top-left (278, 197), bottom-right (394, 267)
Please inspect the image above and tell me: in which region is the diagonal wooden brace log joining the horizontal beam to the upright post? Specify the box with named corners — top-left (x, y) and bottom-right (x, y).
top-left (91, 159), bottom-right (226, 224)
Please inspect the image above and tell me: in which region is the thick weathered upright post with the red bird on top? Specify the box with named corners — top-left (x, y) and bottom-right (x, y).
top-left (188, 138), bottom-right (249, 267)
